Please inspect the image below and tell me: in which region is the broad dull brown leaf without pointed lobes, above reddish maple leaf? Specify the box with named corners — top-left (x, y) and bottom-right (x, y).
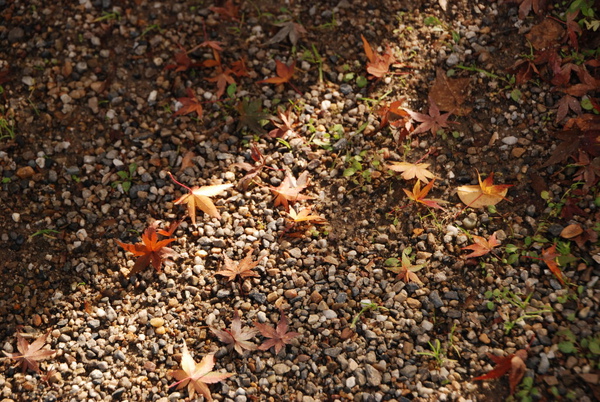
top-left (429, 68), bottom-right (471, 116)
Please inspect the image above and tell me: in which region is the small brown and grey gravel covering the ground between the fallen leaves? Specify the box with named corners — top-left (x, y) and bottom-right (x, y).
top-left (0, 0), bottom-right (600, 402)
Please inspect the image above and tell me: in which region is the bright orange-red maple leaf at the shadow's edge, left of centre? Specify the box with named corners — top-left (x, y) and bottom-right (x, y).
top-left (117, 221), bottom-right (179, 276)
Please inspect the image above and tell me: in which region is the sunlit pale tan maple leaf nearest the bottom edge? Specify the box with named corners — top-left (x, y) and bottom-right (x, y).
top-left (169, 341), bottom-right (233, 401)
